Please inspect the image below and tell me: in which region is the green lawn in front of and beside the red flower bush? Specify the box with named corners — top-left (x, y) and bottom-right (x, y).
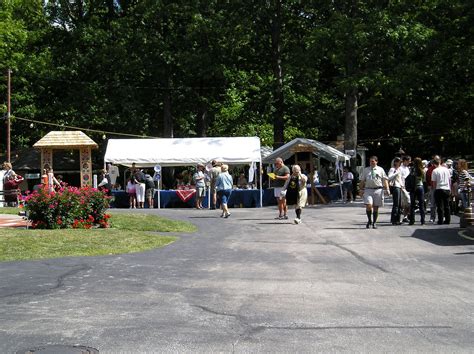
top-left (0, 208), bottom-right (196, 261)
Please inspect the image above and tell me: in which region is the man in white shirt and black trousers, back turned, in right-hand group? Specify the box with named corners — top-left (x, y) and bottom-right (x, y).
top-left (431, 159), bottom-right (451, 225)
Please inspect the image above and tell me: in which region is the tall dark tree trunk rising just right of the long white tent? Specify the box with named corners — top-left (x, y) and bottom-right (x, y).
top-left (272, 0), bottom-right (285, 149)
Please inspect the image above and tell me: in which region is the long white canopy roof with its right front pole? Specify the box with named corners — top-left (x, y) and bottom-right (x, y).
top-left (104, 137), bottom-right (262, 207)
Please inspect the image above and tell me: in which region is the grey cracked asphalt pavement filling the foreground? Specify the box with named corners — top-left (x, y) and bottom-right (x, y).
top-left (0, 204), bottom-right (474, 353)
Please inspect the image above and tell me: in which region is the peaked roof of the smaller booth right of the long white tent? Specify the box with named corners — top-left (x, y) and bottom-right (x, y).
top-left (263, 138), bottom-right (351, 165)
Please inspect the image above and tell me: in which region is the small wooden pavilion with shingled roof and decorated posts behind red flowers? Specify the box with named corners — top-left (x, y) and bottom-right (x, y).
top-left (33, 131), bottom-right (98, 187)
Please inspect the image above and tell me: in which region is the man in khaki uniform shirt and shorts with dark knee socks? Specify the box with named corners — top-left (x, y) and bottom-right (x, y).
top-left (360, 156), bottom-right (390, 229)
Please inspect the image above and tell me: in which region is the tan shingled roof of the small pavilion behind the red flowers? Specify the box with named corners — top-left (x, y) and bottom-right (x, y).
top-left (33, 130), bottom-right (98, 149)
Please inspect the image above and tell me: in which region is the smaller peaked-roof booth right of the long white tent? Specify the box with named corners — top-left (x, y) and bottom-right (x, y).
top-left (262, 138), bottom-right (350, 203)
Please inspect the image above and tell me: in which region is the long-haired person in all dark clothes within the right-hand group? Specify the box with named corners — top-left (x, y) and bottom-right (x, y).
top-left (405, 157), bottom-right (425, 225)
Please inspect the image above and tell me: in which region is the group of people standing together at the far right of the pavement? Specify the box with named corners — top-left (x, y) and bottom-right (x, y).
top-left (360, 155), bottom-right (473, 229)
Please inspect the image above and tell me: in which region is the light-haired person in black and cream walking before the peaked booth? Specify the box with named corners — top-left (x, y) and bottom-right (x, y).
top-left (281, 165), bottom-right (308, 224)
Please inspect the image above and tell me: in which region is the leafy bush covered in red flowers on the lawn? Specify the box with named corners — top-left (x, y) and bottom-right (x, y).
top-left (23, 187), bottom-right (110, 229)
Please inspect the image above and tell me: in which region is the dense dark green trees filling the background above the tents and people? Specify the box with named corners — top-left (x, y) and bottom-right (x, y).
top-left (0, 0), bottom-right (474, 160)
